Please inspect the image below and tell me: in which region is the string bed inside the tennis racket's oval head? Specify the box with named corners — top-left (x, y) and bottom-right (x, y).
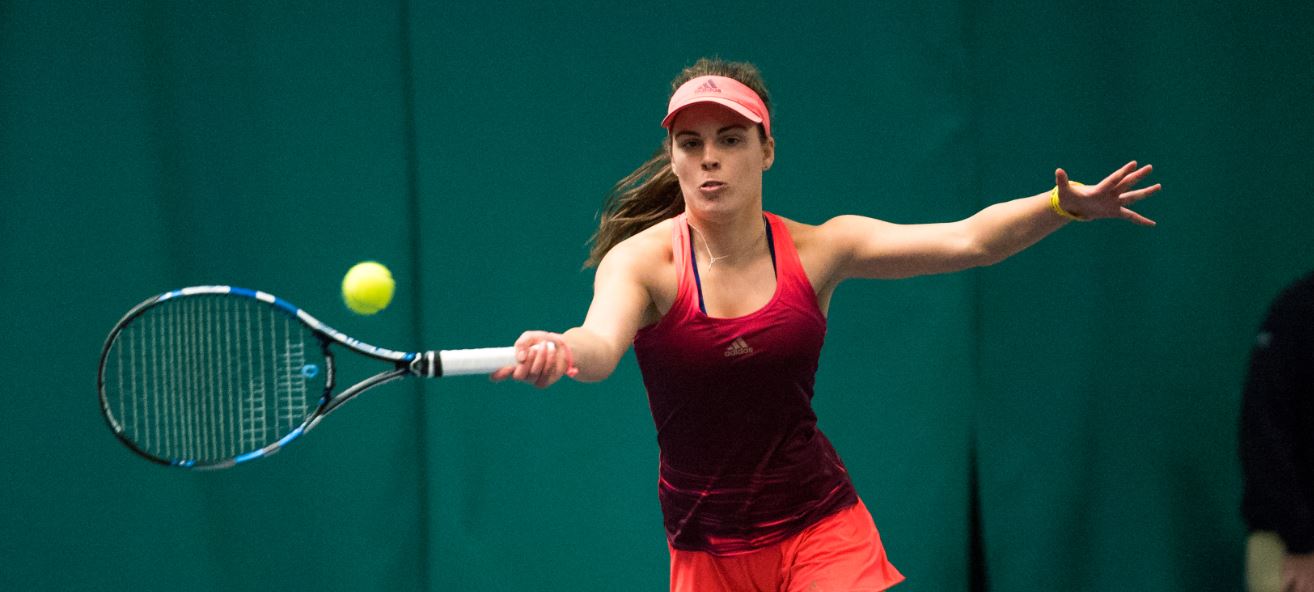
top-left (105, 295), bottom-right (327, 463)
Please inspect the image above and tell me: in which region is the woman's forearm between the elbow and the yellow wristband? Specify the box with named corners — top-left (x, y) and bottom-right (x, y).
top-left (963, 192), bottom-right (1068, 265)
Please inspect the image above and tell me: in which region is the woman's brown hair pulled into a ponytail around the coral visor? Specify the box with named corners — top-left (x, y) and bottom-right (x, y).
top-left (583, 58), bottom-right (771, 268)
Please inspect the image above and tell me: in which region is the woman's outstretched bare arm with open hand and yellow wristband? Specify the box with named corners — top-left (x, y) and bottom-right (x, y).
top-left (820, 161), bottom-right (1160, 280)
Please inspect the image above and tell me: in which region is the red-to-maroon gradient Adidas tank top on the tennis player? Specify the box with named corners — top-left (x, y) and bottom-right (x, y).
top-left (635, 214), bottom-right (858, 555)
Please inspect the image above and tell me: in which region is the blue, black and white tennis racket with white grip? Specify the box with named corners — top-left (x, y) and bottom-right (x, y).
top-left (97, 286), bottom-right (515, 469)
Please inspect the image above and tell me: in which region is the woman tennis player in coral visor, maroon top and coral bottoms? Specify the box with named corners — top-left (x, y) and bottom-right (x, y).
top-left (493, 59), bottom-right (1159, 592)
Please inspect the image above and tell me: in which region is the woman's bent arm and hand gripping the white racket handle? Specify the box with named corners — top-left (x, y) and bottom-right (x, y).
top-left (491, 243), bottom-right (652, 389)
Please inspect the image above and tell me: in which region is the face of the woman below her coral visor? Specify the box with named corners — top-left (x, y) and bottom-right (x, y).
top-left (670, 102), bottom-right (775, 221)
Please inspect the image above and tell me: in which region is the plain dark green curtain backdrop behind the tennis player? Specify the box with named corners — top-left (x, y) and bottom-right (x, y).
top-left (0, 0), bottom-right (1314, 591)
